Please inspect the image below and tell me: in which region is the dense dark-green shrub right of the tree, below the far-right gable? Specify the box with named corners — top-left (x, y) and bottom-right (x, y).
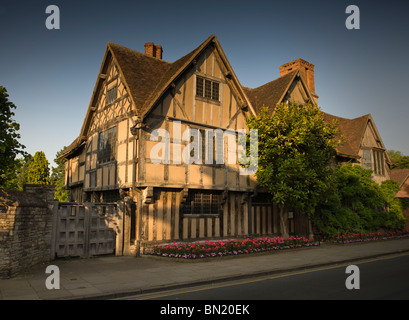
top-left (312, 165), bottom-right (406, 236)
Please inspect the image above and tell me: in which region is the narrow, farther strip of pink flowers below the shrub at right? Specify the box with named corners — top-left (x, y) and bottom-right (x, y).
top-left (321, 230), bottom-right (409, 243)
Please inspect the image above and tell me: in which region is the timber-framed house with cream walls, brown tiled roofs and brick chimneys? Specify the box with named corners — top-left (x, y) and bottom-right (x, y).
top-left (60, 35), bottom-right (388, 250)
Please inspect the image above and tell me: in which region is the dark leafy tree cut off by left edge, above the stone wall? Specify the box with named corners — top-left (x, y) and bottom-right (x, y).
top-left (0, 86), bottom-right (25, 188)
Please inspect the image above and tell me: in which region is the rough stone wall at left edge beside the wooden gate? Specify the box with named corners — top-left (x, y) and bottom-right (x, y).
top-left (0, 186), bottom-right (53, 279)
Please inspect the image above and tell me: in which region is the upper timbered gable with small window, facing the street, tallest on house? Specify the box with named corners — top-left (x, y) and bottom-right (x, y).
top-left (146, 46), bottom-right (250, 130)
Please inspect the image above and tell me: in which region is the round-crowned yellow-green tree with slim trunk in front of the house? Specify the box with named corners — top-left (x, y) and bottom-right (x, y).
top-left (247, 103), bottom-right (340, 237)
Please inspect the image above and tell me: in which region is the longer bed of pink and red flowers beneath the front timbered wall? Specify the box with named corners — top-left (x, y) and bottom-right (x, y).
top-left (151, 236), bottom-right (319, 259)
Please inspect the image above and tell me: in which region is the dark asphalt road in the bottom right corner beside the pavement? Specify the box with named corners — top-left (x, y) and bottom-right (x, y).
top-left (133, 253), bottom-right (409, 300)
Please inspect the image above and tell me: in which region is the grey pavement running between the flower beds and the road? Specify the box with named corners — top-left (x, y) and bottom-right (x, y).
top-left (0, 238), bottom-right (409, 300)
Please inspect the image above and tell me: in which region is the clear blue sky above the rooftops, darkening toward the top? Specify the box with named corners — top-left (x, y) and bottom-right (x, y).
top-left (0, 0), bottom-right (409, 166)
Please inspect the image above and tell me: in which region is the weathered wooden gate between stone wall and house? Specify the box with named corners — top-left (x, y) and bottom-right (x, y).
top-left (51, 203), bottom-right (118, 258)
